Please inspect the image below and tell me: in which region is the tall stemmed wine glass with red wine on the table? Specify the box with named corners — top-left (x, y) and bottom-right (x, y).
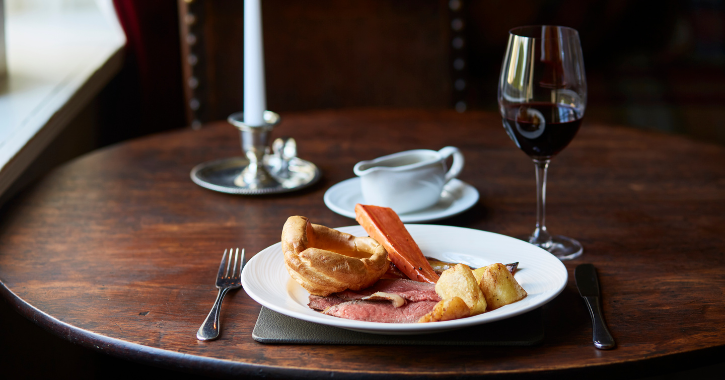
top-left (498, 25), bottom-right (587, 260)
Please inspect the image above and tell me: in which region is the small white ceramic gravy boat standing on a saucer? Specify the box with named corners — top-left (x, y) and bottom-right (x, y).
top-left (353, 146), bottom-right (465, 214)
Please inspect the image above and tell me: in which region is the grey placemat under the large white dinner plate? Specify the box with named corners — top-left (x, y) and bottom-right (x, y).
top-left (252, 306), bottom-right (544, 346)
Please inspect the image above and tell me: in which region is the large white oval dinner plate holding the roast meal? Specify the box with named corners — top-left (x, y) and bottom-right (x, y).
top-left (242, 224), bottom-right (568, 335)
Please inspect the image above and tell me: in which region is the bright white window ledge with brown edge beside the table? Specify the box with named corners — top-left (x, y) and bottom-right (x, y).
top-left (0, 0), bottom-right (125, 199)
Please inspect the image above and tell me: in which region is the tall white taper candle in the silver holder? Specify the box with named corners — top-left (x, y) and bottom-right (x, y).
top-left (244, 0), bottom-right (267, 126)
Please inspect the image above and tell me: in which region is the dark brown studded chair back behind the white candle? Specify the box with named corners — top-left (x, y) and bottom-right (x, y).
top-left (179, 0), bottom-right (464, 126)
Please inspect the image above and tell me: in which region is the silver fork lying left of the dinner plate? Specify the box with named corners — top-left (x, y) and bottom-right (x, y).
top-left (196, 248), bottom-right (244, 340)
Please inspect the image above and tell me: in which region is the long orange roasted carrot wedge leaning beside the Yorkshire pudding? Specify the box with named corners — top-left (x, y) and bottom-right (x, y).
top-left (355, 204), bottom-right (438, 284)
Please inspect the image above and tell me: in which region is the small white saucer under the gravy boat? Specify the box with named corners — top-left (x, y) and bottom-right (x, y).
top-left (324, 177), bottom-right (478, 223)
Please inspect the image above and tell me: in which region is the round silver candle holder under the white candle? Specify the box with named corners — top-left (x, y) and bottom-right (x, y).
top-left (191, 111), bottom-right (320, 195)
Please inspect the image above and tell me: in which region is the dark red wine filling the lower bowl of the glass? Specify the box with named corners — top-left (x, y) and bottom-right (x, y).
top-left (503, 102), bottom-right (582, 159)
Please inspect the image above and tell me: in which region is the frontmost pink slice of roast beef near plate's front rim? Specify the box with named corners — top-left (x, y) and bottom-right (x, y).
top-left (323, 300), bottom-right (438, 323)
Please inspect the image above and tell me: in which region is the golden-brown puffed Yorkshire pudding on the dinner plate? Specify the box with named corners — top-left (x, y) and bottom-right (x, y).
top-left (282, 216), bottom-right (389, 296)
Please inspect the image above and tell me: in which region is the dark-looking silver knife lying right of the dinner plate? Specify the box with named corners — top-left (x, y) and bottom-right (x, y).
top-left (574, 264), bottom-right (616, 350)
